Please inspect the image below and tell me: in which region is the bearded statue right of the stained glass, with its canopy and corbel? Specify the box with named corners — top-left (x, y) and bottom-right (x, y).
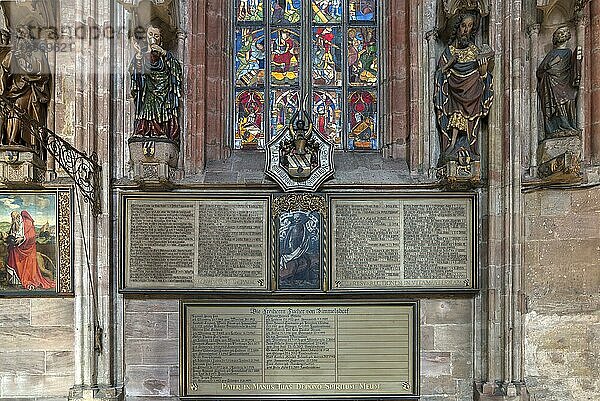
top-left (433, 1), bottom-right (494, 186)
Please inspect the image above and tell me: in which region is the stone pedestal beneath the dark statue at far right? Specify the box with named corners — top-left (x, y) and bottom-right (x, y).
top-left (538, 134), bottom-right (581, 182)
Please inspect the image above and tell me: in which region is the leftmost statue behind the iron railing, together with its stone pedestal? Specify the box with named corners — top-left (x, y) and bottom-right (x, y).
top-left (0, 25), bottom-right (51, 186)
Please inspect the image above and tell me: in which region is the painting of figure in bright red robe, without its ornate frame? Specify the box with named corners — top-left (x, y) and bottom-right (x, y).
top-left (0, 194), bottom-right (56, 292)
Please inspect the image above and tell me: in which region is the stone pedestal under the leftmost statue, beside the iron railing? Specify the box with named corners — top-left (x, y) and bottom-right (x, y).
top-left (0, 146), bottom-right (46, 186)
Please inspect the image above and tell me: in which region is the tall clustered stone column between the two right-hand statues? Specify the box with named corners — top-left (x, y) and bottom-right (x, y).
top-left (475, 2), bottom-right (529, 401)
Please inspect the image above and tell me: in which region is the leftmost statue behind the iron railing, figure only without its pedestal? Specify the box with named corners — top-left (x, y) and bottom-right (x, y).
top-left (0, 26), bottom-right (50, 151)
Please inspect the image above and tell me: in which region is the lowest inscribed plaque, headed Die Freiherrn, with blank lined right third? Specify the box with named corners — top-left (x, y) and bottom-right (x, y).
top-left (180, 303), bottom-right (418, 399)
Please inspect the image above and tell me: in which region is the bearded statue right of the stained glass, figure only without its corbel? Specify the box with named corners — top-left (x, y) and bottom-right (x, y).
top-left (434, 12), bottom-right (494, 167)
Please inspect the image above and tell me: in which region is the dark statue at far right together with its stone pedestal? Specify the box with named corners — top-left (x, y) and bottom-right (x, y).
top-left (536, 26), bottom-right (583, 178)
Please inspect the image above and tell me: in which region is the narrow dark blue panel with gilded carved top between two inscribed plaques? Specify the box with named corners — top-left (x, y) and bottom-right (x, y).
top-left (271, 193), bottom-right (327, 292)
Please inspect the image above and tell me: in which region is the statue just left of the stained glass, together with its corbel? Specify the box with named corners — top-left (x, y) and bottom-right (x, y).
top-left (129, 24), bottom-right (183, 186)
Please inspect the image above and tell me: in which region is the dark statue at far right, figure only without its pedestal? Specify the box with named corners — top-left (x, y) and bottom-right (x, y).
top-left (537, 26), bottom-right (583, 137)
